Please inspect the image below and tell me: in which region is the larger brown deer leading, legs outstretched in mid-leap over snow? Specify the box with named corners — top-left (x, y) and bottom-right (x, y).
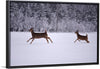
top-left (27, 28), bottom-right (53, 44)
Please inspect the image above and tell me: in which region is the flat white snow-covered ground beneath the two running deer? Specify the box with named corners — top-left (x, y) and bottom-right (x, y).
top-left (11, 32), bottom-right (97, 66)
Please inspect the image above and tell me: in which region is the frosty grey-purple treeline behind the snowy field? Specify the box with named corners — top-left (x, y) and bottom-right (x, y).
top-left (10, 2), bottom-right (97, 32)
